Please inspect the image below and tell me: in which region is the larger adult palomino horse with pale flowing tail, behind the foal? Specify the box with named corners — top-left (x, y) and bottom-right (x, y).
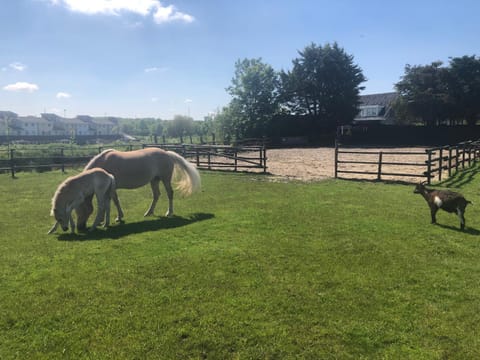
top-left (76, 148), bottom-right (201, 228)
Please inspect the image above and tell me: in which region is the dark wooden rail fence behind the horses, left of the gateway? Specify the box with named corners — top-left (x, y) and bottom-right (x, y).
top-left (0, 144), bottom-right (267, 177)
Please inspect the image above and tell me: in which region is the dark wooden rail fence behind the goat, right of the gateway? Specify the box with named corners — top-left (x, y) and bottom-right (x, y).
top-left (334, 141), bottom-right (480, 184)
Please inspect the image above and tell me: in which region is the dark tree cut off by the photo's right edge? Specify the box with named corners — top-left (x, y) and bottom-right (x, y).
top-left (448, 56), bottom-right (480, 125)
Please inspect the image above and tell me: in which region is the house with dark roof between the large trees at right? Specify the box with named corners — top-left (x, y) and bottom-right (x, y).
top-left (353, 92), bottom-right (398, 125)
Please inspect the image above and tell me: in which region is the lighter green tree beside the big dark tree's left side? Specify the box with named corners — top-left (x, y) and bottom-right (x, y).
top-left (227, 58), bottom-right (278, 138)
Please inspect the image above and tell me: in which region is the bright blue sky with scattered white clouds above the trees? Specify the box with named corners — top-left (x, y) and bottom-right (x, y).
top-left (0, 0), bottom-right (480, 119)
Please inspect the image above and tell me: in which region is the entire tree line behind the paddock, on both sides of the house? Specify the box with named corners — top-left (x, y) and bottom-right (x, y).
top-left (119, 43), bottom-right (480, 142)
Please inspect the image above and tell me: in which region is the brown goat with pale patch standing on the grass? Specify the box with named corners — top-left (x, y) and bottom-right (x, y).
top-left (413, 183), bottom-right (472, 230)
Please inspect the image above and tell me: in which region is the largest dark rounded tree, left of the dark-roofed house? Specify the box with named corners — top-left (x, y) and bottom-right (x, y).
top-left (280, 43), bottom-right (366, 125)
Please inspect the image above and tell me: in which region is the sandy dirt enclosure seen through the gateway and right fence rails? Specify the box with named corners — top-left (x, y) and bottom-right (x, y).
top-left (267, 147), bottom-right (427, 182)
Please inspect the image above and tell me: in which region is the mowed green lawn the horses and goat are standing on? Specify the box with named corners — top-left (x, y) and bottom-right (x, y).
top-left (0, 169), bottom-right (480, 359)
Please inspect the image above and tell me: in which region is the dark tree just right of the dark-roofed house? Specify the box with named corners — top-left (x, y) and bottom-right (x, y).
top-left (395, 61), bottom-right (451, 126)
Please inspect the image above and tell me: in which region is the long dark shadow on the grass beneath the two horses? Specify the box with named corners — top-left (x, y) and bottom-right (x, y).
top-left (58, 213), bottom-right (215, 241)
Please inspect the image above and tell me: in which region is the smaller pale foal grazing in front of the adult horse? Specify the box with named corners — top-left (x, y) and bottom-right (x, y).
top-left (48, 168), bottom-right (117, 234)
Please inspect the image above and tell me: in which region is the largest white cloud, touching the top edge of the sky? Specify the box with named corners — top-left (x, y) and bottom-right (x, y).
top-left (50, 0), bottom-right (195, 24)
